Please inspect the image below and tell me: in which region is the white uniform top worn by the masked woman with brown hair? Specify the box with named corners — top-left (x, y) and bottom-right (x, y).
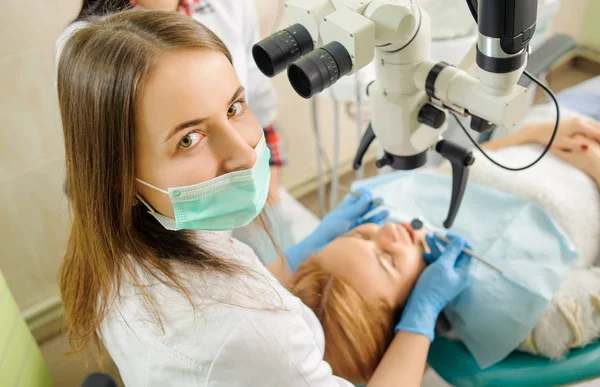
top-left (100, 232), bottom-right (352, 387)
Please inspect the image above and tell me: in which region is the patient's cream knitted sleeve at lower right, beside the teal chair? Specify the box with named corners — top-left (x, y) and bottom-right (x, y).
top-left (518, 267), bottom-right (600, 359)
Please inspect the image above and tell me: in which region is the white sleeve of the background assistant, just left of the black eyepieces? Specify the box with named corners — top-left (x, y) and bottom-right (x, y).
top-left (242, 0), bottom-right (277, 128)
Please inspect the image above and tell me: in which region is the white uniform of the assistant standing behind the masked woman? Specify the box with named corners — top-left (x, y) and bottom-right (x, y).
top-left (55, 0), bottom-right (277, 128)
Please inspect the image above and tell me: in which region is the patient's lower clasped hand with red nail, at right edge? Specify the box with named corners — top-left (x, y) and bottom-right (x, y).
top-left (550, 135), bottom-right (600, 187)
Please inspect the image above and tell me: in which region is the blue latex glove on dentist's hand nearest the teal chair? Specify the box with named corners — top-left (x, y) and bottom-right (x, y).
top-left (395, 233), bottom-right (471, 341)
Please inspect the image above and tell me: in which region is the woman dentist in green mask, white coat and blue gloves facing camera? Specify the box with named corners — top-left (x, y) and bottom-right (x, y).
top-left (58, 11), bottom-right (469, 386)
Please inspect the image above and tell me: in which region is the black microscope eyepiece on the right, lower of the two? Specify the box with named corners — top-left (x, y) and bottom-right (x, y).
top-left (288, 41), bottom-right (352, 98)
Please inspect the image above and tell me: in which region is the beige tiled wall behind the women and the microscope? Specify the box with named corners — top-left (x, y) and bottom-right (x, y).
top-left (0, 0), bottom-right (597, 316)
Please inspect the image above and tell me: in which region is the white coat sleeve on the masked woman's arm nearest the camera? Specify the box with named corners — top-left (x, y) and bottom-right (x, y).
top-left (207, 310), bottom-right (353, 387)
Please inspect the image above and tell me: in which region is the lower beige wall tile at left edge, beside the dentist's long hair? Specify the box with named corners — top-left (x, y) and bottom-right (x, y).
top-left (0, 160), bottom-right (69, 309)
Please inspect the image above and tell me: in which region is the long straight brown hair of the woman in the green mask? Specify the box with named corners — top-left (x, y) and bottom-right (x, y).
top-left (58, 11), bottom-right (248, 358)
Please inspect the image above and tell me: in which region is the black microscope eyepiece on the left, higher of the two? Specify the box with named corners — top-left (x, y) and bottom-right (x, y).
top-left (252, 24), bottom-right (314, 77)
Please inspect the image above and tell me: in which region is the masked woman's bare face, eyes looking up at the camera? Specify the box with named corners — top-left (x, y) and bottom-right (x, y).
top-left (135, 49), bottom-right (262, 217)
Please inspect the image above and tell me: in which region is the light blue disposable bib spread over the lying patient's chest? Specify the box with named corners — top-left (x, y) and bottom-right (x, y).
top-left (352, 171), bottom-right (579, 369)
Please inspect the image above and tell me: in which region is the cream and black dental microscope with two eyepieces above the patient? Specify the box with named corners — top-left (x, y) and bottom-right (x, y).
top-left (252, 0), bottom-right (538, 228)
